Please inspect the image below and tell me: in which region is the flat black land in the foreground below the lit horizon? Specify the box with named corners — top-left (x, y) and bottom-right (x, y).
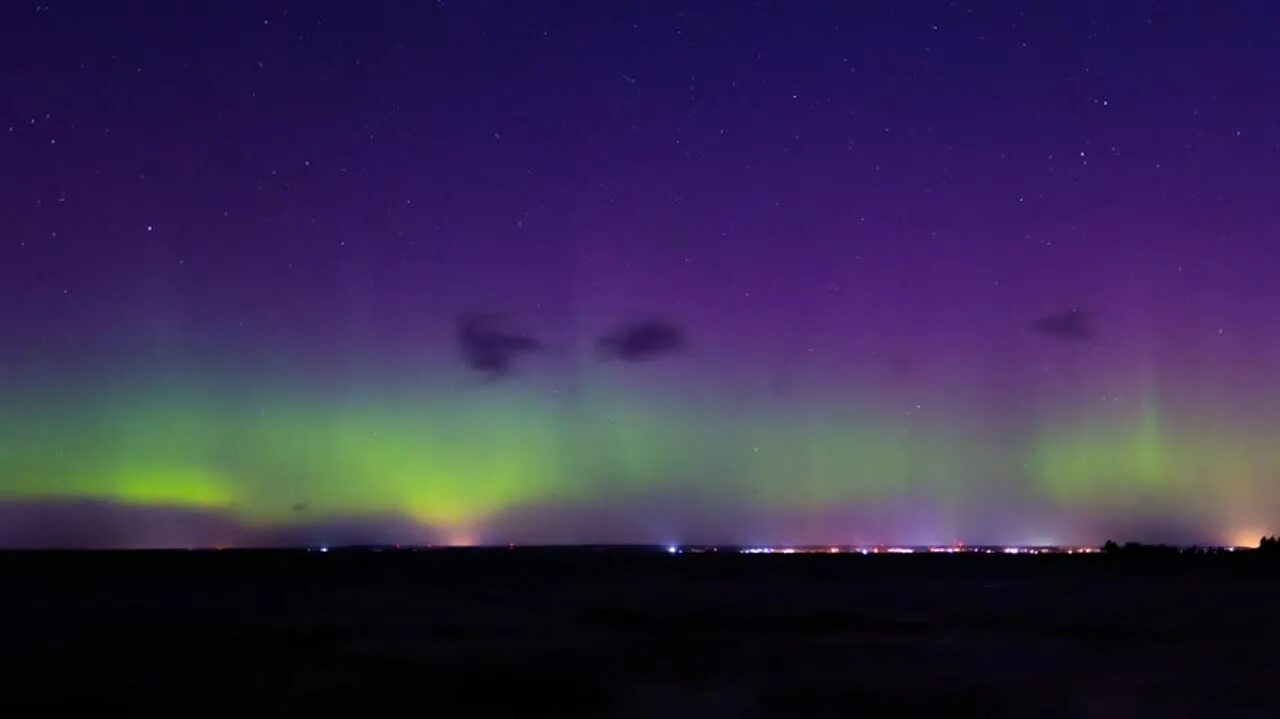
top-left (0, 550), bottom-right (1280, 716)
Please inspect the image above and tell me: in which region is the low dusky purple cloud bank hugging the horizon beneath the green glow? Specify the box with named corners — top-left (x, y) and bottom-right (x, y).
top-left (0, 493), bottom-right (1222, 549)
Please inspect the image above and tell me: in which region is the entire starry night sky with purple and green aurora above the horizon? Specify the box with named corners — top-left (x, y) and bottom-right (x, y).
top-left (0, 0), bottom-right (1280, 546)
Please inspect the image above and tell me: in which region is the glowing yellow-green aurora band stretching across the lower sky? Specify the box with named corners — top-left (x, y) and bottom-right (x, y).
top-left (0, 368), bottom-right (1280, 537)
